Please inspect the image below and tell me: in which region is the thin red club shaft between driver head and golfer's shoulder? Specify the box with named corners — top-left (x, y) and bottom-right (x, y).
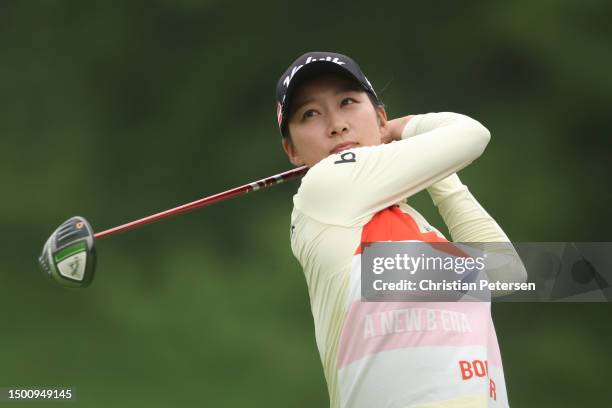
top-left (94, 166), bottom-right (308, 239)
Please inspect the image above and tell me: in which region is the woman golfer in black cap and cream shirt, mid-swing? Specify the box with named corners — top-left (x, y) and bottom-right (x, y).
top-left (276, 52), bottom-right (521, 408)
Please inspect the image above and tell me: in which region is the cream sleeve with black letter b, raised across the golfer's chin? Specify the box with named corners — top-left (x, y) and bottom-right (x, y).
top-left (294, 112), bottom-right (490, 227)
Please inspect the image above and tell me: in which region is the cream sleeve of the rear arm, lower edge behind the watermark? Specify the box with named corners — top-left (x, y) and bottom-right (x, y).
top-left (427, 174), bottom-right (527, 296)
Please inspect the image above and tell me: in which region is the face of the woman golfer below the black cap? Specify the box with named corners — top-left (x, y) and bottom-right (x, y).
top-left (283, 75), bottom-right (388, 167)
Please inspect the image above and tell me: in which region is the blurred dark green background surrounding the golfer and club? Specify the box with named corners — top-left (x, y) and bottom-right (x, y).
top-left (0, 0), bottom-right (612, 407)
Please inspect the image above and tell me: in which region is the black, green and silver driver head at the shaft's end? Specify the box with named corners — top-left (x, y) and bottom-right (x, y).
top-left (38, 217), bottom-right (96, 288)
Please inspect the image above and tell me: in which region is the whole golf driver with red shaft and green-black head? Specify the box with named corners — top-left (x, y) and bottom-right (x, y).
top-left (38, 166), bottom-right (308, 288)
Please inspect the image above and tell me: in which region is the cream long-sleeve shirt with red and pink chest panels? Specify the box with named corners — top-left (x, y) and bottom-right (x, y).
top-left (291, 113), bottom-right (515, 408)
